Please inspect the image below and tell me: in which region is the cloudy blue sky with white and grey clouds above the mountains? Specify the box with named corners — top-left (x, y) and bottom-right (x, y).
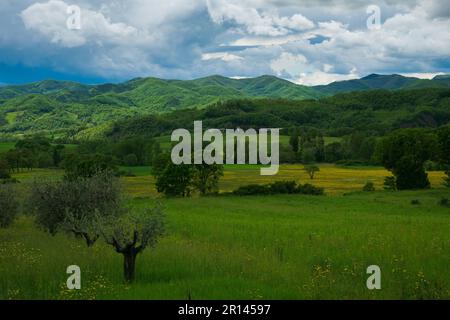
top-left (0, 0), bottom-right (450, 85)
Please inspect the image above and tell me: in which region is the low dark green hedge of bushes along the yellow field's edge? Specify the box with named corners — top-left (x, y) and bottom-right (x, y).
top-left (233, 181), bottom-right (325, 196)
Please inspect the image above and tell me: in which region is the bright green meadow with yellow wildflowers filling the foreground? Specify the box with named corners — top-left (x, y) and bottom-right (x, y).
top-left (0, 166), bottom-right (450, 299)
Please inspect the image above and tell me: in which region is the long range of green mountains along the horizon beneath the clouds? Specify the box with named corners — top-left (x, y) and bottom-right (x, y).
top-left (0, 74), bottom-right (450, 139)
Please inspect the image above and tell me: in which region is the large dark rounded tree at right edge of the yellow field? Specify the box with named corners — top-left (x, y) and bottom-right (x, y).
top-left (379, 129), bottom-right (437, 190)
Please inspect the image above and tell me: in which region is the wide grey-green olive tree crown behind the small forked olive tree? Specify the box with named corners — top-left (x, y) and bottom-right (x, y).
top-left (29, 174), bottom-right (123, 246)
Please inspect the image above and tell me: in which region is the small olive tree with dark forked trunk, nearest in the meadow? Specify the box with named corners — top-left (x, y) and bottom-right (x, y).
top-left (100, 206), bottom-right (165, 282)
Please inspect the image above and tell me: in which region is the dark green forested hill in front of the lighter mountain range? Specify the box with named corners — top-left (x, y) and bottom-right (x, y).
top-left (107, 89), bottom-right (450, 139)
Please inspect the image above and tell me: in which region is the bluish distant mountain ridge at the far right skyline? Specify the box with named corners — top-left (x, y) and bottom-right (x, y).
top-left (313, 74), bottom-right (450, 95)
